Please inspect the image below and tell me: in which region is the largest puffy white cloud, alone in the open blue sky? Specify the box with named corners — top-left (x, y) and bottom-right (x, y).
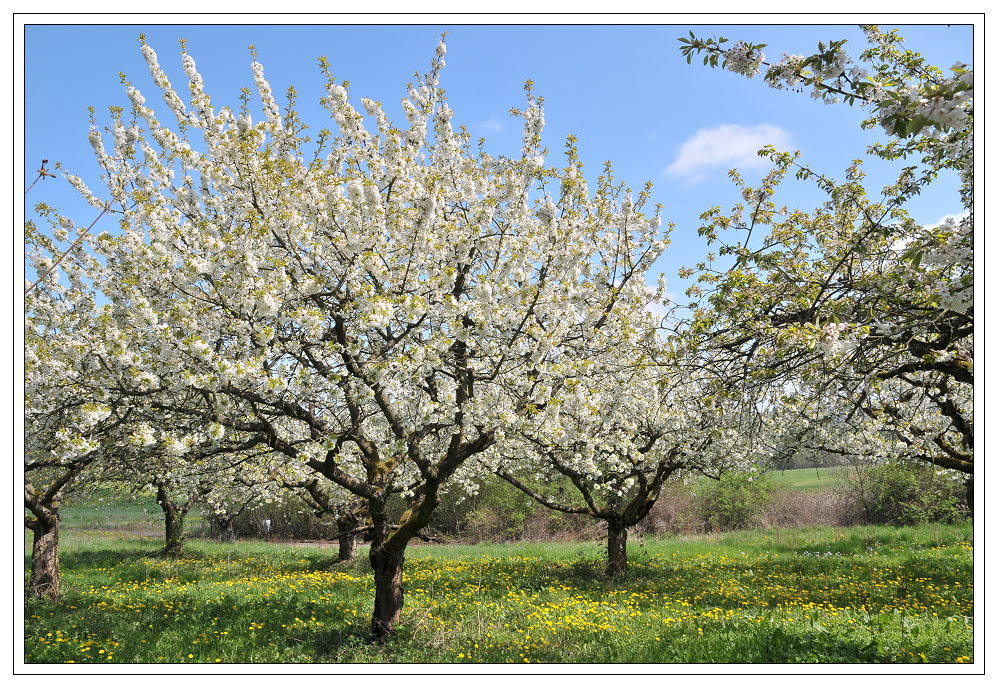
top-left (664, 124), bottom-right (790, 182)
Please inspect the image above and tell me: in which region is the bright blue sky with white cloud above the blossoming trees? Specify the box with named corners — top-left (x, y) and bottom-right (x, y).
top-left (23, 20), bottom-right (974, 300)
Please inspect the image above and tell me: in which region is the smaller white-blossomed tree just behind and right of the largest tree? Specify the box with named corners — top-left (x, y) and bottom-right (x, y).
top-left (484, 328), bottom-right (759, 576)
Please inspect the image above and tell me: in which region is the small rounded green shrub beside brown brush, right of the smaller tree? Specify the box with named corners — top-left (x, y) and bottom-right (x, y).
top-left (692, 472), bottom-right (773, 531)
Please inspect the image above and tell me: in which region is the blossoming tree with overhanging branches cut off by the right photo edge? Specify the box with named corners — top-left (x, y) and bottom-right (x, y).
top-left (681, 26), bottom-right (974, 503)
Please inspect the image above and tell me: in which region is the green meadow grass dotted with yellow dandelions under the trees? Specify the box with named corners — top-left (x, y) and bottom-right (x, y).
top-left (25, 525), bottom-right (973, 664)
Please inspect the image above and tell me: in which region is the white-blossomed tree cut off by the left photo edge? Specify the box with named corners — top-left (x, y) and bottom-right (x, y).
top-left (24, 219), bottom-right (131, 599)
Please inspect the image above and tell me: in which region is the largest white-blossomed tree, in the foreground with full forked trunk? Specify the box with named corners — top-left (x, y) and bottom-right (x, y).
top-left (66, 37), bottom-right (664, 639)
